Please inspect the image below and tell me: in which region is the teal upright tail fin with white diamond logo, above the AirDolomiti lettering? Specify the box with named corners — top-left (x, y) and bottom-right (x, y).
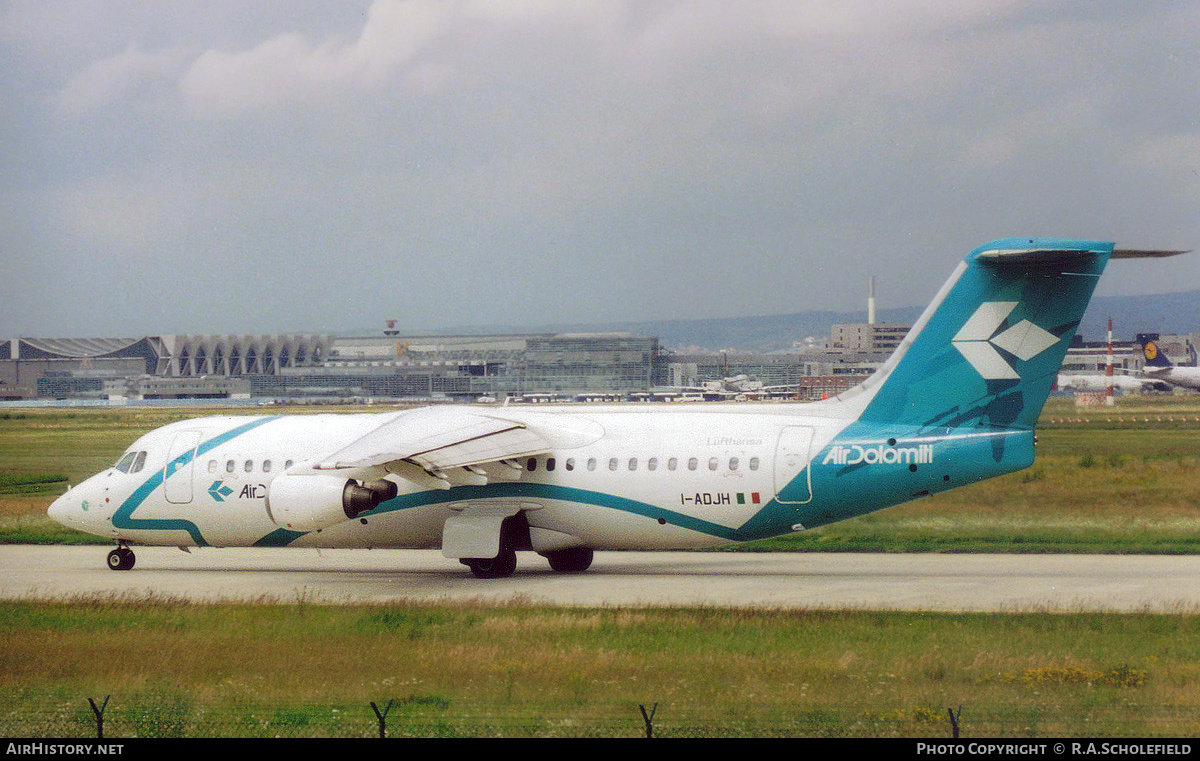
top-left (844, 238), bottom-right (1178, 430)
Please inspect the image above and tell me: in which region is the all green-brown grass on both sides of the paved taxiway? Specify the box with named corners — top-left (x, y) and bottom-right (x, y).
top-left (0, 397), bottom-right (1200, 737)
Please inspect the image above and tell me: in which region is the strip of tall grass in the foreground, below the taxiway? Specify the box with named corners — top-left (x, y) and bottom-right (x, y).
top-left (0, 599), bottom-right (1200, 737)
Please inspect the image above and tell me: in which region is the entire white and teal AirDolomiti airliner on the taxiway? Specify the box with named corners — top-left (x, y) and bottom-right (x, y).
top-left (49, 239), bottom-right (1178, 577)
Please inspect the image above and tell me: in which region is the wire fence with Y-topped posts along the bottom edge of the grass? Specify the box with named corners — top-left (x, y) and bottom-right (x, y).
top-left (0, 695), bottom-right (1200, 738)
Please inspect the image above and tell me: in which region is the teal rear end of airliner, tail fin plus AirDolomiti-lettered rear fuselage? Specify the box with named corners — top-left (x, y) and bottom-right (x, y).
top-left (742, 238), bottom-right (1181, 537)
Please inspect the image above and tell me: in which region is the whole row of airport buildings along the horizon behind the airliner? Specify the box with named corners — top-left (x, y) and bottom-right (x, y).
top-left (0, 325), bottom-right (1193, 402)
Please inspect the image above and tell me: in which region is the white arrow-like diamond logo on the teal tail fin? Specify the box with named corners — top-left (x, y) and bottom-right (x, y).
top-left (950, 301), bottom-right (1058, 381)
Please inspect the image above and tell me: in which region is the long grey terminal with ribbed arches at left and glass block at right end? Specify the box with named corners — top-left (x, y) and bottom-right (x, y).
top-left (0, 334), bottom-right (667, 401)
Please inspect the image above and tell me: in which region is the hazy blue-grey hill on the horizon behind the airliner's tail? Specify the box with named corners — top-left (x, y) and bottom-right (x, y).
top-left (369, 290), bottom-right (1200, 352)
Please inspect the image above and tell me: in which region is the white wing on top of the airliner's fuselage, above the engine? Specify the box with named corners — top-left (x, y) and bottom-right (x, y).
top-left (313, 407), bottom-right (551, 489)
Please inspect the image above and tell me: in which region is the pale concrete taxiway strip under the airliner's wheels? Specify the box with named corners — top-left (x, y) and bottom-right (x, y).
top-left (0, 545), bottom-right (1200, 612)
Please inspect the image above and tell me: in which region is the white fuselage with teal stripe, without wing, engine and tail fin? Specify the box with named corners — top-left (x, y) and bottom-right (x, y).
top-left (52, 403), bottom-right (1032, 549)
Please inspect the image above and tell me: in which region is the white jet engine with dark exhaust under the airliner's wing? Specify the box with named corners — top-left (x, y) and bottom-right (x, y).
top-left (266, 473), bottom-right (396, 532)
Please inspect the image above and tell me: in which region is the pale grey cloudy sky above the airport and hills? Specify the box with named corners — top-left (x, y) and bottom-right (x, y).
top-left (0, 0), bottom-right (1200, 337)
